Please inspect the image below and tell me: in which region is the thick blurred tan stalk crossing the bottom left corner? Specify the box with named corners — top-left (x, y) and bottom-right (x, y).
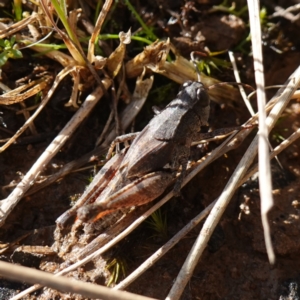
top-left (0, 261), bottom-right (157, 300)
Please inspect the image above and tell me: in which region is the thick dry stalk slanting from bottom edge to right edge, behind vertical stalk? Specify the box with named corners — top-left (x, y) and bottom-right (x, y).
top-left (166, 67), bottom-right (300, 300)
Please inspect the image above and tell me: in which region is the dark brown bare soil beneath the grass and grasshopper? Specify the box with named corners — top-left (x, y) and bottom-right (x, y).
top-left (0, 1), bottom-right (300, 300)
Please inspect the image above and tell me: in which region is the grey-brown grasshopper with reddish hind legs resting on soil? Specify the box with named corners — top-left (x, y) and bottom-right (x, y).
top-left (57, 81), bottom-right (210, 232)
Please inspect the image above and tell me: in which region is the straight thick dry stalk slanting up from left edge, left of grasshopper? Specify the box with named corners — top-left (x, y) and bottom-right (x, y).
top-left (0, 79), bottom-right (111, 225)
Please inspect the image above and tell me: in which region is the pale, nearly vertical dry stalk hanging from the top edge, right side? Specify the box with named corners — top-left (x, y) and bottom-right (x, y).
top-left (248, 0), bottom-right (275, 264)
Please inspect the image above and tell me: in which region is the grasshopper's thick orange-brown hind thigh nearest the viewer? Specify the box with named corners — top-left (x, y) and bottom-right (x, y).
top-left (77, 171), bottom-right (174, 221)
